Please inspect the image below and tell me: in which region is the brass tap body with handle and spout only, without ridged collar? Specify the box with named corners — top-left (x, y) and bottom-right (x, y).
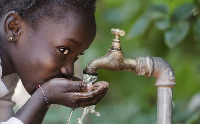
top-left (83, 29), bottom-right (139, 75)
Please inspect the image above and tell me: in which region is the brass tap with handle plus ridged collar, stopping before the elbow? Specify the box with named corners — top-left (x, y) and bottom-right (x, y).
top-left (83, 28), bottom-right (153, 76)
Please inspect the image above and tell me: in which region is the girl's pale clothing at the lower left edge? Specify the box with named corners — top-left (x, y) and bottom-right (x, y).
top-left (0, 60), bottom-right (23, 124)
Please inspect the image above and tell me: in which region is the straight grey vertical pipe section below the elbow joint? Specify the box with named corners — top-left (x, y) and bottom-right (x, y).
top-left (157, 87), bottom-right (173, 124)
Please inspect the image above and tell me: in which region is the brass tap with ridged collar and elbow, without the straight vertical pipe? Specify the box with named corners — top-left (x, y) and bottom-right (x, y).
top-left (83, 29), bottom-right (175, 83)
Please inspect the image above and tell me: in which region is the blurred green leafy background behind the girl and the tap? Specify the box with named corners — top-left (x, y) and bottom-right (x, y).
top-left (44, 0), bottom-right (200, 124)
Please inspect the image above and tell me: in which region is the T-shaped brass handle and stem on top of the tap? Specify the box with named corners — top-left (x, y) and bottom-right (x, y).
top-left (111, 28), bottom-right (125, 51)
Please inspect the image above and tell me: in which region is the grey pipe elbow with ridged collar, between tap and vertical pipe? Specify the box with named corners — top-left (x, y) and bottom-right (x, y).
top-left (135, 56), bottom-right (176, 86)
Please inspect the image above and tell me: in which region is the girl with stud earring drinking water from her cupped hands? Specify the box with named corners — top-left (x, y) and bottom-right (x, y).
top-left (0, 0), bottom-right (108, 124)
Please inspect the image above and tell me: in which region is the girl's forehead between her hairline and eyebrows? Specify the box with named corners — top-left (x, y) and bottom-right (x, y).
top-left (31, 12), bottom-right (96, 47)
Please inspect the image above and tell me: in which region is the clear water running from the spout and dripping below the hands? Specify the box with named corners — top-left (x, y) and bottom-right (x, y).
top-left (67, 74), bottom-right (100, 124)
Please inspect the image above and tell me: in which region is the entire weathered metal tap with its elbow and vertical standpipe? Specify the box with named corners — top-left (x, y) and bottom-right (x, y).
top-left (83, 29), bottom-right (176, 124)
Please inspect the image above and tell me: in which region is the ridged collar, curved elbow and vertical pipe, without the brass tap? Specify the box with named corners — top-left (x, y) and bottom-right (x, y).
top-left (136, 57), bottom-right (176, 124)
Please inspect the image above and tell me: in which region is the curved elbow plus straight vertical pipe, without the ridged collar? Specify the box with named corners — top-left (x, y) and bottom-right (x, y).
top-left (152, 57), bottom-right (176, 124)
